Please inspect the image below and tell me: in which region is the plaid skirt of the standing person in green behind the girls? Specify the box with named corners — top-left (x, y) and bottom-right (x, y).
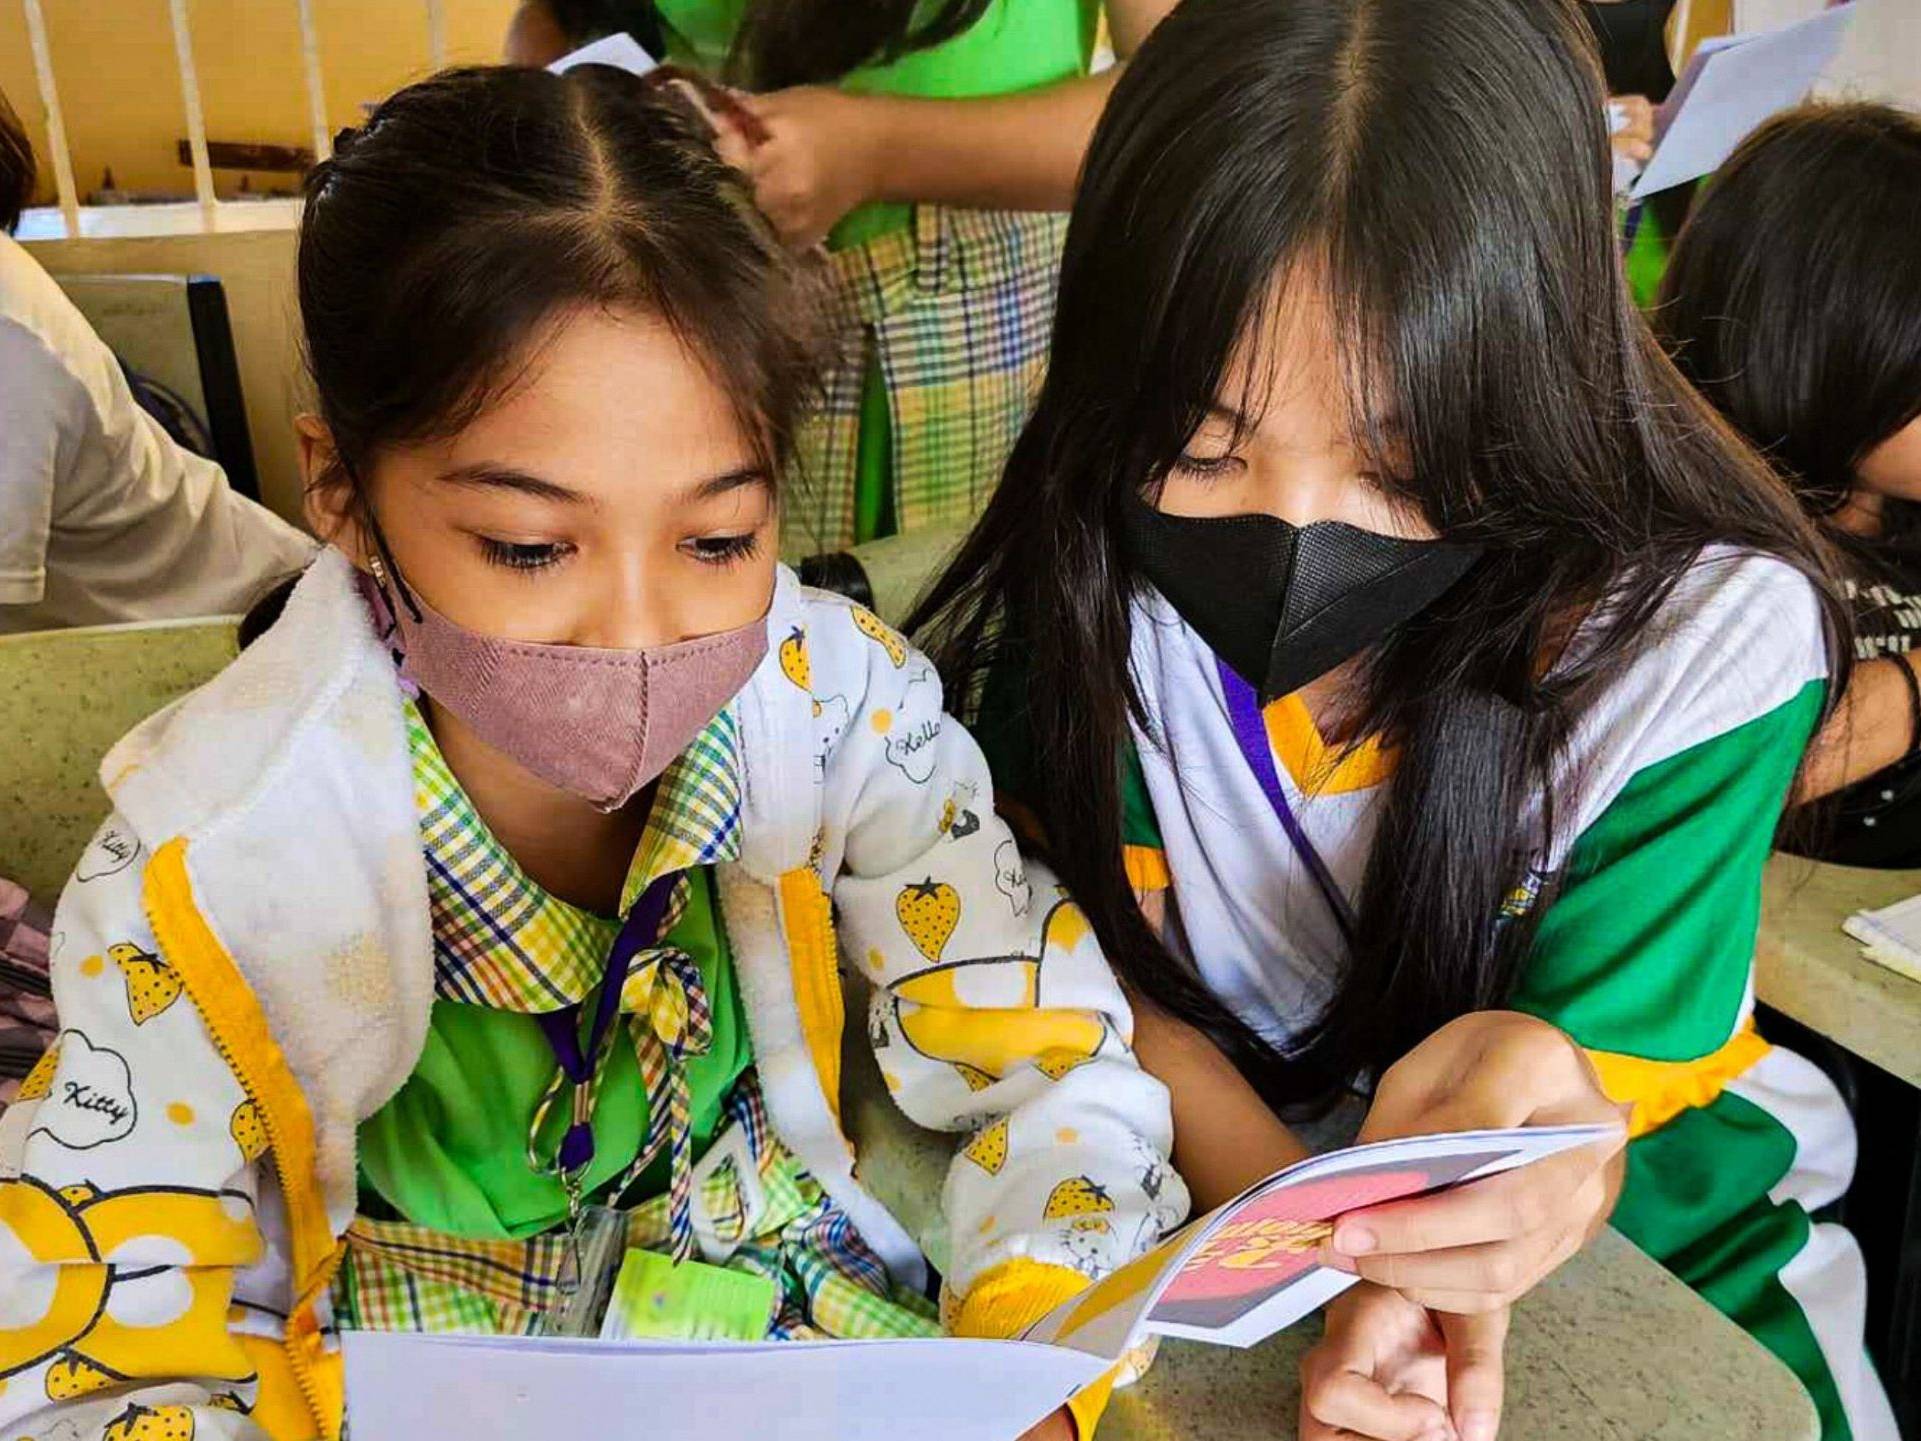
top-left (782, 206), bottom-right (1066, 559)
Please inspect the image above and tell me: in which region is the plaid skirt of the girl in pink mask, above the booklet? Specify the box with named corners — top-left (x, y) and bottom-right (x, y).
top-left (334, 1070), bottom-right (939, 1339)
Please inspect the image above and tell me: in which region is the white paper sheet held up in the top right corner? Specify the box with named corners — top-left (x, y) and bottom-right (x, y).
top-left (1629, 4), bottom-right (1854, 200)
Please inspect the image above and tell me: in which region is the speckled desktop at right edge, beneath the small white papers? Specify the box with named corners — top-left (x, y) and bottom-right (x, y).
top-left (1754, 855), bottom-right (1921, 1086)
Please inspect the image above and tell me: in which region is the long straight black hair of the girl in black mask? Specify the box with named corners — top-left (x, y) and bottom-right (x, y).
top-left (914, 0), bottom-right (1846, 1103)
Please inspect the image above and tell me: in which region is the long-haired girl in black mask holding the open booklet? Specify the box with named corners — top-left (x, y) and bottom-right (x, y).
top-left (918, 0), bottom-right (1894, 1441)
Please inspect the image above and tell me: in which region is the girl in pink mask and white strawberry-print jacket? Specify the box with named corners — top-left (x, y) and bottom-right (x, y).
top-left (0, 67), bottom-right (1187, 1437)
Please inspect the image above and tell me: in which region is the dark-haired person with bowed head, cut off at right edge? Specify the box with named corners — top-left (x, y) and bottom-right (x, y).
top-left (1658, 104), bottom-right (1921, 868)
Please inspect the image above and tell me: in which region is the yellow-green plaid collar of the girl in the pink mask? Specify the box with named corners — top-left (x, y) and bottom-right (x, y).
top-left (405, 699), bottom-right (742, 1013)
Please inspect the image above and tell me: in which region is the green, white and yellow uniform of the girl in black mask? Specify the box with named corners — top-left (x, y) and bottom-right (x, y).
top-left (1126, 550), bottom-right (1894, 1441)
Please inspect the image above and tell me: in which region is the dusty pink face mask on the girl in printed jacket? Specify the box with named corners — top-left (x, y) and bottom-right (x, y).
top-left (365, 557), bottom-right (766, 811)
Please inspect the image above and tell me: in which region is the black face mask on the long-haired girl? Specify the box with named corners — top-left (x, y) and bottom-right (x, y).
top-left (1122, 496), bottom-right (1481, 705)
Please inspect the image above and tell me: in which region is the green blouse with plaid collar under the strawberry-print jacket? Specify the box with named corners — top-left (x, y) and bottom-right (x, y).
top-left (359, 705), bottom-right (753, 1239)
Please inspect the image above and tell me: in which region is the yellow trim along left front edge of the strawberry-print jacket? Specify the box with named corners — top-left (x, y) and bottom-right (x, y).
top-left (144, 838), bottom-right (346, 1441)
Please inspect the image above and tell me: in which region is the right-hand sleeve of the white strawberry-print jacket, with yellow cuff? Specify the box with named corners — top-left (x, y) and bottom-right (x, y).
top-left (822, 607), bottom-right (1187, 1335)
